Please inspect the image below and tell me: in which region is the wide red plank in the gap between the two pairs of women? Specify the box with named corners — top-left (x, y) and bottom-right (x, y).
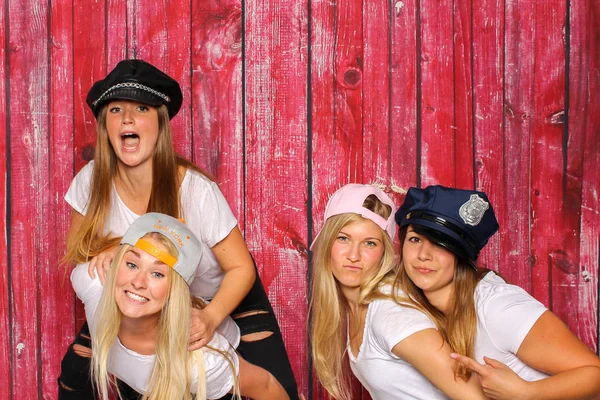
top-left (244, 1), bottom-right (308, 392)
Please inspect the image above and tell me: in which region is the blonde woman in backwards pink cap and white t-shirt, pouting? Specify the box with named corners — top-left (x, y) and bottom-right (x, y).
top-left (311, 184), bottom-right (484, 400)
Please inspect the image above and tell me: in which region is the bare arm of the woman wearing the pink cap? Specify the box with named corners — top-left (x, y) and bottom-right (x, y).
top-left (392, 329), bottom-right (486, 400)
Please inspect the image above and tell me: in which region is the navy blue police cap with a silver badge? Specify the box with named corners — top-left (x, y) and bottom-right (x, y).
top-left (396, 185), bottom-right (499, 261)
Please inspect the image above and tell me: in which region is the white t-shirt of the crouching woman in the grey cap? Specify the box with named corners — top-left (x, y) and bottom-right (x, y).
top-left (71, 263), bottom-right (239, 399)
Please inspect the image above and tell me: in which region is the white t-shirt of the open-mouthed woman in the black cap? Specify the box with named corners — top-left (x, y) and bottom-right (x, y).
top-left (65, 161), bottom-right (237, 299)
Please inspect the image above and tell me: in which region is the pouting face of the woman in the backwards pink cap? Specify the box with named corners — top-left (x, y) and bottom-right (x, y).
top-left (330, 219), bottom-right (385, 301)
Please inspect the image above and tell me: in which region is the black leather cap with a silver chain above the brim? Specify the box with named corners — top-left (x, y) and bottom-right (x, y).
top-left (86, 60), bottom-right (183, 119)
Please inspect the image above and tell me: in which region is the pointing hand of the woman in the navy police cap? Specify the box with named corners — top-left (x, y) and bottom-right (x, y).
top-left (450, 353), bottom-right (528, 400)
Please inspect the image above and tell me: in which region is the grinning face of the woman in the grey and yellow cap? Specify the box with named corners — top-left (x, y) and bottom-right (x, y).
top-left (115, 237), bottom-right (171, 319)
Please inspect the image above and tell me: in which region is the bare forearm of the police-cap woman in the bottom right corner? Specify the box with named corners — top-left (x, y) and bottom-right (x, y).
top-left (527, 366), bottom-right (600, 400)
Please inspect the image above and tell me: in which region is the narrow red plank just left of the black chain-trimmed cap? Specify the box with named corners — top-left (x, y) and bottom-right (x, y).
top-left (38, 0), bottom-right (75, 393)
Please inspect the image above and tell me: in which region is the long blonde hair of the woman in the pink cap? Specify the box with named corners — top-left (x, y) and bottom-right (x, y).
top-left (310, 195), bottom-right (396, 400)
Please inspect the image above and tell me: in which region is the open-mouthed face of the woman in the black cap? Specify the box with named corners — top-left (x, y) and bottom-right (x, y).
top-left (106, 100), bottom-right (159, 167)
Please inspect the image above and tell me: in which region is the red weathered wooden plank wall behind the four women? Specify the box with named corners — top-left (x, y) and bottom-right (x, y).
top-left (0, 0), bottom-right (600, 399)
